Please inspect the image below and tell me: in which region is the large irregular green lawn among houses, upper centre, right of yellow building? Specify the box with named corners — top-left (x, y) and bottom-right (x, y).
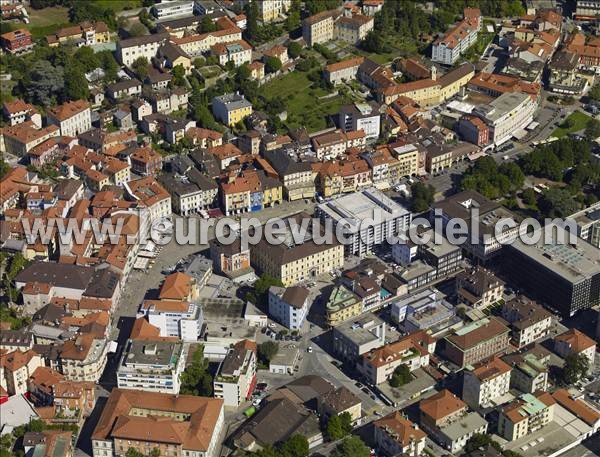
top-left (261, 71), bottom-right (352, 132)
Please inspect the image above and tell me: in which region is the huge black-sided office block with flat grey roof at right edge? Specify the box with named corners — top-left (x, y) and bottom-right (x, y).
top-left (507, 224), bottom-right (600, 316)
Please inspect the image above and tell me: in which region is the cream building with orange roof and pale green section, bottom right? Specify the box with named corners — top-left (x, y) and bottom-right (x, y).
top-left (498, 392), bottom-right (556, 441)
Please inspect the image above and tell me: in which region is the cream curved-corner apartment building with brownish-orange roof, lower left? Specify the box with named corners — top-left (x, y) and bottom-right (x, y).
top-left (59, 333), bottom-right (109, 382)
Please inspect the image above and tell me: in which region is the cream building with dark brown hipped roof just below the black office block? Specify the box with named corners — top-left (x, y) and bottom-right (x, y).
top-left (501, 296), bottom-right (552, 348)
